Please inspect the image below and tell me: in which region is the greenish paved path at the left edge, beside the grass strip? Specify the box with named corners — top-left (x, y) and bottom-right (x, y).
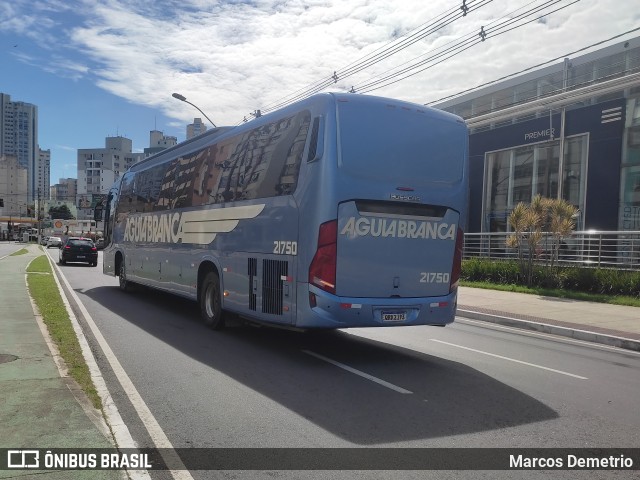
top-left (0, 246), bottom-right (123, 479)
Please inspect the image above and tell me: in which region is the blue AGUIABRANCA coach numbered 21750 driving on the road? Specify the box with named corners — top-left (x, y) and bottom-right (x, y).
top-left (103, 93), bottom-right (469, 330)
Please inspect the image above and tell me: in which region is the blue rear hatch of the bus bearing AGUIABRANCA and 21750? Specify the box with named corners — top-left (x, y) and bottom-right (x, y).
top-left (336, 200), bottom-right (459, 298)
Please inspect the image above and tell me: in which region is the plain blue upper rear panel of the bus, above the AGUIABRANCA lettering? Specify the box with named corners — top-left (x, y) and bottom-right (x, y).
top-left (338, 102), bottom-right (467, 186)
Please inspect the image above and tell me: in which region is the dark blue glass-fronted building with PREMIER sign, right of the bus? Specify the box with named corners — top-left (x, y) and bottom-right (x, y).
top-left (432, 37), bottom-right (640, 232)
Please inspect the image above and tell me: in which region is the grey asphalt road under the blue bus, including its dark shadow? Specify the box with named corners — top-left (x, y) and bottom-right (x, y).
top-left (48, 249), bottom-right (640, 479)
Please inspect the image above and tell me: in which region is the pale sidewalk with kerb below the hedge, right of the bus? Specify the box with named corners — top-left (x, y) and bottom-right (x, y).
top-left (458, 287), bottom-right (640, 351)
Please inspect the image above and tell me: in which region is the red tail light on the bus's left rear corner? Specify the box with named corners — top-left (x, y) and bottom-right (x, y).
top-left (309, 220), bottom-right (338, 294)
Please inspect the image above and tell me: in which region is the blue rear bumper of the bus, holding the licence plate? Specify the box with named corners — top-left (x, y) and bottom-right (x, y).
top-left (296, 284), bottom-right (458, 328)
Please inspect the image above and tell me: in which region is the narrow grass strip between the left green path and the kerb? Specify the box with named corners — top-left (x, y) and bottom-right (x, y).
top-left (27, 255), bottom-right (102, 410)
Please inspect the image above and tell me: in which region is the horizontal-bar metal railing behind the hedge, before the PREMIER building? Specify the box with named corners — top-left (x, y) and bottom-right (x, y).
top-left (463, 230), bottom-right (640, 270)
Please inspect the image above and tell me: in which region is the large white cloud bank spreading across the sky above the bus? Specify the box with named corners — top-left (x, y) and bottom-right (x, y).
top-left (5, 0), bottom-right (638, 124)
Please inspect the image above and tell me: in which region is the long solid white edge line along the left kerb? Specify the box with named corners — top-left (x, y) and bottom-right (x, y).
top-left (47, 249), bottom-right (193, 480)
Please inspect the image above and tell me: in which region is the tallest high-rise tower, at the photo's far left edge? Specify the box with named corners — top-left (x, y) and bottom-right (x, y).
top-left (0, 93), bottom-right (40, 203)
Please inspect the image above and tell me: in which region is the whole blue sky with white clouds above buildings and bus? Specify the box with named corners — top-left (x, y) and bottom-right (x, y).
top-left (0, 0), bottom-right (640, 185)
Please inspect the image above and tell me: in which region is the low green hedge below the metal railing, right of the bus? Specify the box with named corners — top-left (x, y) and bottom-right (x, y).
top-left (461, 258), bottom-right (640, 298)
